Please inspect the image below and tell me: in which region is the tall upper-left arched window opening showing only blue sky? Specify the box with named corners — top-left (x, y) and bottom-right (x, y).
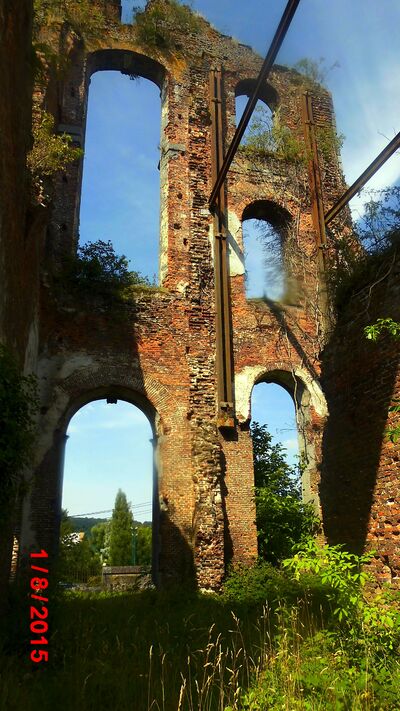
top-left (79, 69), bottom-right (160, 282)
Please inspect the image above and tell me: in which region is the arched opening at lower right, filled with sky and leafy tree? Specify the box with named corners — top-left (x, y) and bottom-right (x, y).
top-left (251, 382), bottom-right (316, 564)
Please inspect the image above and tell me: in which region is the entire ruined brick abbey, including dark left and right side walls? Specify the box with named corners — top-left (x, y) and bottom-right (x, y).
top-left (0, 0), bottom-right (400, 589)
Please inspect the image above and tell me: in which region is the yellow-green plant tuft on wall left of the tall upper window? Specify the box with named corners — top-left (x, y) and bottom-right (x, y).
top-left (27, 112), bottom-right (83, 205)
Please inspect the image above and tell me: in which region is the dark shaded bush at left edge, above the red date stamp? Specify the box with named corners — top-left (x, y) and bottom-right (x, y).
top-left (0, 344), bottom-right (37, 507)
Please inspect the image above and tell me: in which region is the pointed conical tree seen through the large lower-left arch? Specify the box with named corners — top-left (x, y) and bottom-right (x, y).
top-left (110, 489), bottom-right (133, 565)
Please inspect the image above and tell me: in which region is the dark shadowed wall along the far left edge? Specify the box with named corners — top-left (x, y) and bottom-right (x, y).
top-left (0, 0), bottom-right (39, 600)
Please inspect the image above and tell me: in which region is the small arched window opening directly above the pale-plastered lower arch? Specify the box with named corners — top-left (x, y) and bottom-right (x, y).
top-left (242, 200), bottom-right (291, 301)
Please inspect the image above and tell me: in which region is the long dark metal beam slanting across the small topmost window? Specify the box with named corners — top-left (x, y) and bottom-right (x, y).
top-left (209, 0), bottom-right (300, 210)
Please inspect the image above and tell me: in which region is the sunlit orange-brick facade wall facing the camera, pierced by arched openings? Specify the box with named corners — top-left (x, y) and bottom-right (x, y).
top-left (19, 3), bottom-right (350, 588)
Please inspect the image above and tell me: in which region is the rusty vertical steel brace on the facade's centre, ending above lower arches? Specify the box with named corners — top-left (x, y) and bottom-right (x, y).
top-left (210, 68), bottom-right (235, 427)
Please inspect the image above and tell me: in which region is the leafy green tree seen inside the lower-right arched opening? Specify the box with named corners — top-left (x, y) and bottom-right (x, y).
top-left (251, 422), bottom-right (319, 565)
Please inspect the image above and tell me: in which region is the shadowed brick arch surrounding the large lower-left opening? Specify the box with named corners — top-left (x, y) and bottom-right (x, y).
top-left (21, 354), bottom-right (176, 583)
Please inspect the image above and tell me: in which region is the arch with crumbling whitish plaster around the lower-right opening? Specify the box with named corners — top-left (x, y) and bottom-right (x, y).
top-left (235, 362), bottom-right (328, 511)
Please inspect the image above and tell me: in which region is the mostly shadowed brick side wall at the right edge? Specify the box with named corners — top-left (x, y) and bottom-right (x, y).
top-left (320, 255), bottom-right (400, 585)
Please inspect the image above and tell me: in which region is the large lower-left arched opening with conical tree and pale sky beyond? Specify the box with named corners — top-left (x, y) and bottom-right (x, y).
top-left (60, 398), bottom-right (156, 586)
